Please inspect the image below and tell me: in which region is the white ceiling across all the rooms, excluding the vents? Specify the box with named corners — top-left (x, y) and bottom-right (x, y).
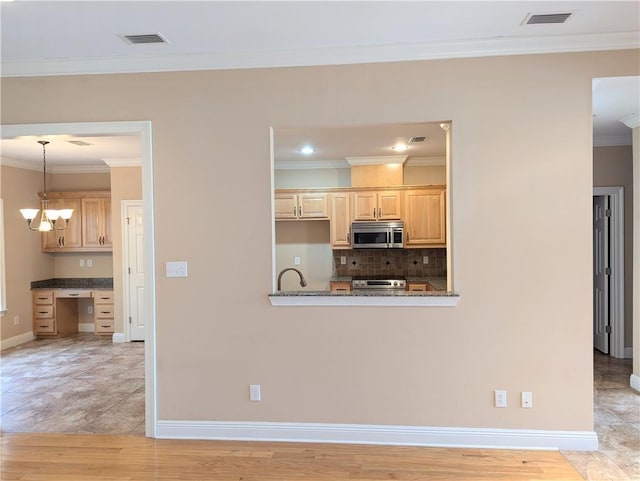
top-left (0, 0), bottom-right (640, 169)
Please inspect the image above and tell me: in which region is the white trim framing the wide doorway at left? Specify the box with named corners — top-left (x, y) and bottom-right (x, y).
top-left (0, 120), bottom-right (158, 438)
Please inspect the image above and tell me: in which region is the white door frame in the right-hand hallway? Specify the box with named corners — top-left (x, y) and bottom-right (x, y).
top-left (592, 186), bottom-right (625, 359)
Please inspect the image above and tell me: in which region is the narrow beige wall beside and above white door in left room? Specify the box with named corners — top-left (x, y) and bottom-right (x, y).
top-left (111, 167), bottom-right (142, 332)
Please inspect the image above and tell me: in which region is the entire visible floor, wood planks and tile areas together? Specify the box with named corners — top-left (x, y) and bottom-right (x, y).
top-left (0, 334), bottom-right (640, 481)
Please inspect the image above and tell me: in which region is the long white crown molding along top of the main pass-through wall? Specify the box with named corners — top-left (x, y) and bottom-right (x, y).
top-left (0, 32), bottom-right (640, 77)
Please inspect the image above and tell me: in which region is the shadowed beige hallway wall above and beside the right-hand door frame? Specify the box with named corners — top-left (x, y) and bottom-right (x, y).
top-left (593, 145), bottom-right (633, 347)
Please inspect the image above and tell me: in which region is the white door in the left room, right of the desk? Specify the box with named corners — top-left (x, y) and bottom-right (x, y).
top-left (125, 201), bottom-right (145, 341)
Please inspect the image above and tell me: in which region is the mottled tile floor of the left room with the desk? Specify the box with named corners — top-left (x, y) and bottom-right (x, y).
top-left (0, 333), bottom-right (144, 435)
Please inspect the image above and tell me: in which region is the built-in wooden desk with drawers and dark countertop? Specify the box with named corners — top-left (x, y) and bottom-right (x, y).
top-left (31, 278), bottom-right (114, 337)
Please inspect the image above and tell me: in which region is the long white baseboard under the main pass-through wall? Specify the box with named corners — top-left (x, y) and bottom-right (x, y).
top-left (155, 421), bottom-right (598, 451)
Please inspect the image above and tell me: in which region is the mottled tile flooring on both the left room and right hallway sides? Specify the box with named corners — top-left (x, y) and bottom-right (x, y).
top-left (0, 334), bottom-right (640, 481)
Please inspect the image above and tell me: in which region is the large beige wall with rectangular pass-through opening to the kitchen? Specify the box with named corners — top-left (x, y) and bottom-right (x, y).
top-left (1, 50), bottom-right (640, 430)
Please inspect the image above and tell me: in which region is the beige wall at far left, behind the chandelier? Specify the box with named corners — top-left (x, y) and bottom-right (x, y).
top-left (0, 165), bottom-right (54, 340)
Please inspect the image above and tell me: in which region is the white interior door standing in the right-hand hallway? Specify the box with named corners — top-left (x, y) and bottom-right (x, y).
top-left (593, 195), bottom-right (610, 354)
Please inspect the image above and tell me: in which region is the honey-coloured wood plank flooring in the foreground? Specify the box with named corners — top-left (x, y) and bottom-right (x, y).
top-left (0, 433), bottom-right (582, 481)
